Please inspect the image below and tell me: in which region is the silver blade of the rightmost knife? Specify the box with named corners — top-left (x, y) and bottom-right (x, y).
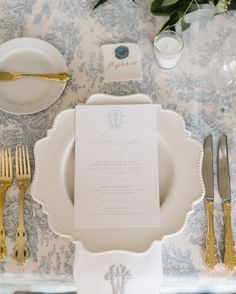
top-left (218, 135), bottom-right (231, 201)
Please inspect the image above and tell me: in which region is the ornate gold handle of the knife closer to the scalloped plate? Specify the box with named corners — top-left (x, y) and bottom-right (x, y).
top-left (204, 201), bottom-right (219, 271)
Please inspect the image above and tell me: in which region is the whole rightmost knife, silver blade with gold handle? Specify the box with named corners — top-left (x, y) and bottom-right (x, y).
top-left (218, 135), bottom-right (236, 272)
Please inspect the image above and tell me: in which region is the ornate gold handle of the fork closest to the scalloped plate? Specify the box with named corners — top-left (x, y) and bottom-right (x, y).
top-left (13, 189), bottom-right (30, 265)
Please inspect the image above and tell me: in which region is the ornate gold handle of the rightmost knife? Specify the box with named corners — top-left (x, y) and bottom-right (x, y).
top-left (223, 203), bottom-right (236, 272)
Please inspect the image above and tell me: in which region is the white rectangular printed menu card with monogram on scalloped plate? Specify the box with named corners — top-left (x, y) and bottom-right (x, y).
top-left (74, 104), bottom-right (160, 228)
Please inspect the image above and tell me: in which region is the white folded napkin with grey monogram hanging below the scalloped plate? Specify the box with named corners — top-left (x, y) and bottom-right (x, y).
top-left (73, 241), bottom-right (162, 294)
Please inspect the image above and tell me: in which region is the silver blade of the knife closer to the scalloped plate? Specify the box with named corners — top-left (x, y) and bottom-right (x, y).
top-left (202, 135), bottom-right (214, 200)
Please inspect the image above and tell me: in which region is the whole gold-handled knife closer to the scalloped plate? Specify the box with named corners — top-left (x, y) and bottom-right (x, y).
top-left (202, 135), bottom-right (219, 271)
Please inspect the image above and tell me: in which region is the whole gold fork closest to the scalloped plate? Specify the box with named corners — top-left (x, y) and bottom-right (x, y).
top-left (13, 145), bottom-right (31, 265)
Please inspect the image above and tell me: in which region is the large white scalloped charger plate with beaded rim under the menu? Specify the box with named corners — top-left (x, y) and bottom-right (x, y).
top-left (32, 94), bottom-right (202, 252)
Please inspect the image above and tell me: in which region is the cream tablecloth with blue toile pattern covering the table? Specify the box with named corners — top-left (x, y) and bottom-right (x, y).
top-left (0, 0), bottom-right (236, 294)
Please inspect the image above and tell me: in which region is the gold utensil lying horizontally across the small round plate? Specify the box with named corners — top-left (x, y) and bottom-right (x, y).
top-left (0, 72), bottom-right (70, 83)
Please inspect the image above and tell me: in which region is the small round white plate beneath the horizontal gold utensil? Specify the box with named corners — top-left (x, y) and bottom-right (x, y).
top-left (0, 38), bottom-right (67, 114)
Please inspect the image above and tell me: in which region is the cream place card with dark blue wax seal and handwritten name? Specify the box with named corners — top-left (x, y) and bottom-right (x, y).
top-left (102, 43), bottom-right (142, 82)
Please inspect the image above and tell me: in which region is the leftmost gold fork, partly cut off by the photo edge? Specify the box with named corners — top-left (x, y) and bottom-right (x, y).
top-left (0, 148), bottom-right (13, 261)
